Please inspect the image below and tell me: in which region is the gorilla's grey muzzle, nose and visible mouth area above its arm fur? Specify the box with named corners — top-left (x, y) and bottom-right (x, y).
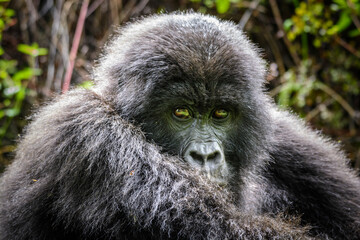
top-left (184, 141), bottom-right (229, 185)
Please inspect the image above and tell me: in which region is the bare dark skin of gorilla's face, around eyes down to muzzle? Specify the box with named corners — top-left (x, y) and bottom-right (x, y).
top-left (171, 105), bottom-right (231, 185)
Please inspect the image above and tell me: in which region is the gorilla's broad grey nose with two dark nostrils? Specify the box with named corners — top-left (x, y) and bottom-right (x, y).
top-left (184, 142), bottom-right (224, 165)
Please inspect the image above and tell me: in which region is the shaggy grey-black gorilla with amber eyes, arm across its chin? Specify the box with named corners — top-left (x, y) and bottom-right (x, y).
top-left (0, 13), bottom-right (360, 240)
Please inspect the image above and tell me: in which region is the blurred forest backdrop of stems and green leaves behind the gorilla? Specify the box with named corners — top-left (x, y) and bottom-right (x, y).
top-left (0, 0), bottom-right (360, 172)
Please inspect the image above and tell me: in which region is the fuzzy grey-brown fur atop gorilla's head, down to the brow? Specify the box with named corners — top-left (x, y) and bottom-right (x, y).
top-left (94, 13), bottom-right (265, 115)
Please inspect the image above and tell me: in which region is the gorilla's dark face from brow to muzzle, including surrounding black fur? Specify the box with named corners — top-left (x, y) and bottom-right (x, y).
top-left (143, 80), bottom-right (238, 185)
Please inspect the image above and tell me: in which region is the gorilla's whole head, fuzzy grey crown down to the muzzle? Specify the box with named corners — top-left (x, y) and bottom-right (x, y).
top-left (95, 14), bottom-right (271, 185)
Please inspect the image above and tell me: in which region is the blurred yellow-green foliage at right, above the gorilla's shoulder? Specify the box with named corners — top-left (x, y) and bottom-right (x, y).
top-left (277, 0), bottom-right (360, 129)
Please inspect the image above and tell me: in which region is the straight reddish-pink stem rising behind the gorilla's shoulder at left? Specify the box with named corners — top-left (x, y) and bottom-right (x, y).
top-left (62, 0), bottom-right (89, 93)
